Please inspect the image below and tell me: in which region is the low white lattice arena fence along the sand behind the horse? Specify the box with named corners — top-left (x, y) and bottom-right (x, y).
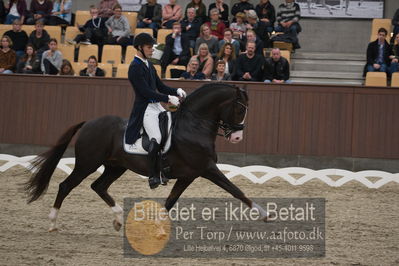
top-left (0, 154), bottom-right (399, 188)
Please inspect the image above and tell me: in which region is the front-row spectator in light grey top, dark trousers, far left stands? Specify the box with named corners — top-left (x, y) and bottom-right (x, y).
top-left (41, 39), bottom-right (62, 75)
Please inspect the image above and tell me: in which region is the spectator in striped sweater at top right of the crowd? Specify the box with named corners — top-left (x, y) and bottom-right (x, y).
top-left (276, 0), bottom-right (301, 37)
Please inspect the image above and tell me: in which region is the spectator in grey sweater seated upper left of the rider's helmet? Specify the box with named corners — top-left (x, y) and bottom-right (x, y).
top-left (105, 4), bottom-right (131, 47)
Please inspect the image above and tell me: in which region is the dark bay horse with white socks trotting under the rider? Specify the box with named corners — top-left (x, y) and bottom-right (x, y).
top-left (26, 83), bottom-right (267, 231)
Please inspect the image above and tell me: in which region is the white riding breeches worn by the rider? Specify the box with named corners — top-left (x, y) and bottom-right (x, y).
top-left (143, 103), bottom-right (171, 144)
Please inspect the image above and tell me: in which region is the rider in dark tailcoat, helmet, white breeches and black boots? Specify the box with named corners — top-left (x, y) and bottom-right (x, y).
top-left (125, 33), bottom-right (186, 189)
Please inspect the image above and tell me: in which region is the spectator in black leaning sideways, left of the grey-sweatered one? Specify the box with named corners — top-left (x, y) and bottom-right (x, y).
top-left (66, 6), bottom-right (108, 46)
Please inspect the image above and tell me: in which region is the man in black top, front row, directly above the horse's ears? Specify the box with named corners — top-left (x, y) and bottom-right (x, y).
top-left (235, 41), bottom-right (264, 81)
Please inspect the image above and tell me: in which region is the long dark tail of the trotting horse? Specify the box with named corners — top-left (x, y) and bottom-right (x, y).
top-left (25, 122), bottom-right (86, 203)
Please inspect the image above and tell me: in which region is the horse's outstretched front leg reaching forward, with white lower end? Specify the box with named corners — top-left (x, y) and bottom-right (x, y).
top-left (202, 165), bottom-right (270, 221)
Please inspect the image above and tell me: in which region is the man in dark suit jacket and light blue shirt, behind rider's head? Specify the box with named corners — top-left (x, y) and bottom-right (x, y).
top-left (161, 22), bottom-right (190, 71)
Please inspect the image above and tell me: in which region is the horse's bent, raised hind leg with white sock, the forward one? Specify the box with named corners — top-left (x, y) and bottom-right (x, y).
top-left (91, 166), bottom-right (126, 231)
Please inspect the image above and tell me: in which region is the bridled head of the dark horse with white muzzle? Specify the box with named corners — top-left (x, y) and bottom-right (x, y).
top-left (220, 87), bottom-right (248, 143)
